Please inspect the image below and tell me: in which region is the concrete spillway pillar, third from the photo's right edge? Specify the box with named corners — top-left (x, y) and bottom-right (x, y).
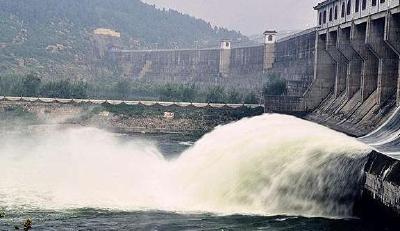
top-left (350, 23), bottom-right (378, 100)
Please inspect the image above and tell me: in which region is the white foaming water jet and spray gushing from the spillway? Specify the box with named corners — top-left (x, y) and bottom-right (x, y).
top-left (0, 115), bottom-right (369, 217)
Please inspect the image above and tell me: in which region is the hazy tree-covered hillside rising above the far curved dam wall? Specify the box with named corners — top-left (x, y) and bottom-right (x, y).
top-left (0, 0), bottom-right (248, 79)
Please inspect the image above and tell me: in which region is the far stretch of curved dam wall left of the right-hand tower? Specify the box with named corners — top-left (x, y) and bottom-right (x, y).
top-left (109, 42), bottom-right (273, 89)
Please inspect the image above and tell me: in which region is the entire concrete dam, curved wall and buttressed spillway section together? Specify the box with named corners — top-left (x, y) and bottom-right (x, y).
top-left (83, 0), bottom-right (400, 221)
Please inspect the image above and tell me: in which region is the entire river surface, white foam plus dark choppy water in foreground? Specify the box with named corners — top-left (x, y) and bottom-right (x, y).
top-left (0, 115), bottom-right (382, 230)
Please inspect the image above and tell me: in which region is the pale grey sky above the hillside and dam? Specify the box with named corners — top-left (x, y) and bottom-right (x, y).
top-left (142, 0), bottom-right (321, 35)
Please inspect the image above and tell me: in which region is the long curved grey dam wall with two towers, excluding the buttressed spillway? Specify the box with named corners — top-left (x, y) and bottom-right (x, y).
top-left (105, 28), bottom-right (316, 96)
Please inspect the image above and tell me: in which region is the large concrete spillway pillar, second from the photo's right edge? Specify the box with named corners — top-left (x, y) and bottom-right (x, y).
top-left (366, 17), bottom-right (399, 105)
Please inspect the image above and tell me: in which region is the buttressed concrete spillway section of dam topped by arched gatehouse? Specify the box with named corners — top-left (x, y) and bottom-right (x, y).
top-left (265, 0), bottom-right (400, 224)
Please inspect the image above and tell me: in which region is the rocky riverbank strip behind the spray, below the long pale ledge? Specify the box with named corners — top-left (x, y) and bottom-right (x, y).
top-left (0, 101), bottom-right (264, 136)
